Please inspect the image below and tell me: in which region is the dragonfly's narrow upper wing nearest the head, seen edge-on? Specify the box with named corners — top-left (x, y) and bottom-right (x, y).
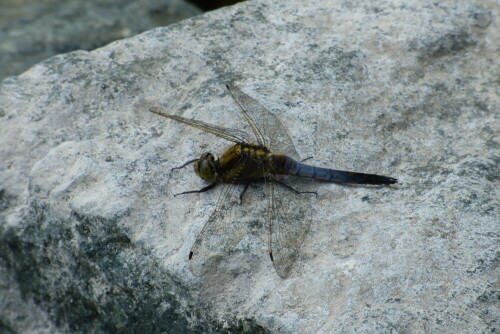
top-left (149, 107), bottom-right (254, 143)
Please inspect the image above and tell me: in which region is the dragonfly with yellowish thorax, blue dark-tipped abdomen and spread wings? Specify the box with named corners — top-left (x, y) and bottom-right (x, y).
top-left (149, 84), bottom-right (397, 278)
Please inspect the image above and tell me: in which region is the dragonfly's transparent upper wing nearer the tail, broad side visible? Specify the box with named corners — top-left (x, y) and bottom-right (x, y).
top-left (226, 85), bottom-right (300, 160)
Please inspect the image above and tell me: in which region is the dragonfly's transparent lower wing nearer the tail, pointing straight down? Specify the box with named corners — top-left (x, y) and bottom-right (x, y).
top-left (266, 175), bottom-right (314, 278)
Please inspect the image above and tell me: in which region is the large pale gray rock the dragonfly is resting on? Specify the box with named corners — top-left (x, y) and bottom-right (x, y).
top-left (0, 0), bottom-right (500, 333)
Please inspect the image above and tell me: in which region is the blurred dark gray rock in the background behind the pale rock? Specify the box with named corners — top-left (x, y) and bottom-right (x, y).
top-left (0, 0), bottom-right (201, 80)
